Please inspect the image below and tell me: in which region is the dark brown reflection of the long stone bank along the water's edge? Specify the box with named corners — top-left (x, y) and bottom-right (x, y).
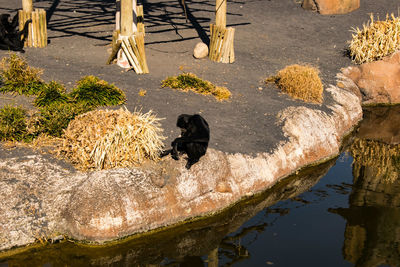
top-left (0, 160), bottom-right (335, 267)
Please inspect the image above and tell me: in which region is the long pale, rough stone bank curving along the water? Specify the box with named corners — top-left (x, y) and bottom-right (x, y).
top-left (0, 86), bottom-right (362, 250)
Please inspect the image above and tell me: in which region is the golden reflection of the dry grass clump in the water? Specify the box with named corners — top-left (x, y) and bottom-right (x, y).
top-left (350, 139), bottom-right (400, 183)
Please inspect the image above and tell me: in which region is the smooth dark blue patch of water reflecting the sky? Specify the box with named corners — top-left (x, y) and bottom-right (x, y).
top-left (220, 154), bottom-right (353, 266)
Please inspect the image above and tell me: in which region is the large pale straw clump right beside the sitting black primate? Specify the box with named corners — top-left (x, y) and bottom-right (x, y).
top-left (59, 108), bottom-right (165, 169)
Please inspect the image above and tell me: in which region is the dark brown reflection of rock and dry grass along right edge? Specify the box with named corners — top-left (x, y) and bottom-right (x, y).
top-left (330, 107), bottom-right (400, 266)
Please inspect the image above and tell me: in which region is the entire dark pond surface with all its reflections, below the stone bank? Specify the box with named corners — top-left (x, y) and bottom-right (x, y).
top-left (0, 106), bottom-right (400, 266)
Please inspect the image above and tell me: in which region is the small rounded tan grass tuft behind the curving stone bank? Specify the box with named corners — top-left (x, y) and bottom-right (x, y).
top-left (266, 64), bottom-right (324, 103)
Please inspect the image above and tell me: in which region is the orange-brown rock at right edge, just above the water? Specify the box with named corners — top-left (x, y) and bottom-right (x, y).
top-left (338, 51), bottom-right (400, 105)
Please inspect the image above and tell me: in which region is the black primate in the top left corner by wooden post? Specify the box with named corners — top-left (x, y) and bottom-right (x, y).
top-left (0, 13), bottom-right (32, 52)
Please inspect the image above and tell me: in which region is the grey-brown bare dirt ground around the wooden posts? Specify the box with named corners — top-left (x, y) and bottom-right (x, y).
top-left (0, 0), bottom-right (400, 154)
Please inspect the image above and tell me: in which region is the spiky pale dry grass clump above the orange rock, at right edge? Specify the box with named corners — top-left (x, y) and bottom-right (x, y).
top-left (350, 14), bottom-right (400, 64)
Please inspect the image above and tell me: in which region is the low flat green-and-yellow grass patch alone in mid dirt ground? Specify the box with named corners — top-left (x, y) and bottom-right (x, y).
top-left (162, 73), bottom-right (231, 101)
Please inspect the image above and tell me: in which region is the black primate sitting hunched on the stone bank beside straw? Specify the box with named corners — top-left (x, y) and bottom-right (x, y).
top-left (161, 114), bottom-right (210, 169)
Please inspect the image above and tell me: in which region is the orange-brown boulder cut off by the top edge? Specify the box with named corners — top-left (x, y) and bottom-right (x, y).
top-left (302, 0), bottom-right (360, 15)
